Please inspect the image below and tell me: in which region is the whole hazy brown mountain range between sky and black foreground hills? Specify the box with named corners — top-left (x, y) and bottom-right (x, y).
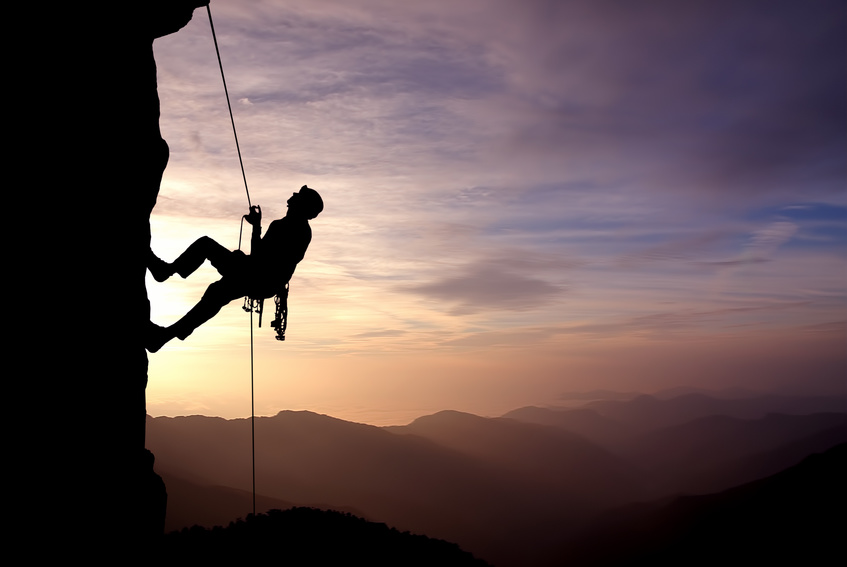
top-left (148, 394), bottom-right (847, 566)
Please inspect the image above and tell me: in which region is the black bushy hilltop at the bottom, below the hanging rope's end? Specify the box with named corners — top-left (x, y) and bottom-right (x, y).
top-left (160, 508), bottom-right (487, 567)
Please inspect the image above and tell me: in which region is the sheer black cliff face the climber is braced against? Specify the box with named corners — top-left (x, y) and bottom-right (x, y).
top-left (15, 0), bottom-right (205, 557)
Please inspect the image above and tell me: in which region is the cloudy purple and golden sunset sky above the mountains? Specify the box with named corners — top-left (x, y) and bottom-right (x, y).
top-left (147, 0), bottom-right (847, 425)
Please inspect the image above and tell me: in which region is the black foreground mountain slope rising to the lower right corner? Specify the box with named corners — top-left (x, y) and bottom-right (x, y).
top-left (551, 444), bottom-right (847, 567)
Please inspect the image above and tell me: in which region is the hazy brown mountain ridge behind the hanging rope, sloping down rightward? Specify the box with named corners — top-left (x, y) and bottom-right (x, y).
top-left (147, 412), bottom-right (623, 565)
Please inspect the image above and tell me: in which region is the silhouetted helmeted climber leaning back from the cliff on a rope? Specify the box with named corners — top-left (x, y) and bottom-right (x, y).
top-left (144, 185), bottom-right (323, 352)
